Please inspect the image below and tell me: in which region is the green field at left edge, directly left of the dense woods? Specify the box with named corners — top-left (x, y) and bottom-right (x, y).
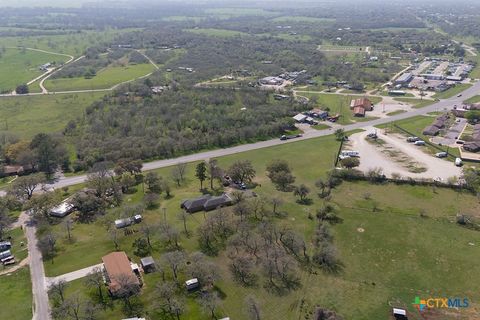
top-left (0, 93), bottom-right (104, 138)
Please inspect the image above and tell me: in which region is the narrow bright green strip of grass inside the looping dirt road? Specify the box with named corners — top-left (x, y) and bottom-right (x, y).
top-left (45, 63), bottom-right (154, 92)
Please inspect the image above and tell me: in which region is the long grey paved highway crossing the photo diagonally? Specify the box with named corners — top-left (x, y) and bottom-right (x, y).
top-left (37, 82), bottom-right (480, 189)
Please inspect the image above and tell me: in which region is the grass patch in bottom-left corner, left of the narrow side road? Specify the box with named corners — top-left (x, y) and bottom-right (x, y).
top-left (0, 267), bottom-right (32, 320)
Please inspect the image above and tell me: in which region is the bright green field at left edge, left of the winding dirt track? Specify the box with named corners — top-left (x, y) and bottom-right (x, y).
top-left (0, 49), bottom-right (68, 92)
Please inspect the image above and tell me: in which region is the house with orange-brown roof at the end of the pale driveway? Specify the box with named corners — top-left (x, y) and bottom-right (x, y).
top-left (102, 251), bottom-right (141, 296)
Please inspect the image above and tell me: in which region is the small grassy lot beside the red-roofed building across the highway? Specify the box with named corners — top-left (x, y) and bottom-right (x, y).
top-left (299, 92), bottom-right (382, 124)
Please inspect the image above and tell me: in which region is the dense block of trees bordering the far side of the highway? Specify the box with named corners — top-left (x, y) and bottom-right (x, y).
top-left (69, 90), bottom-right (301, 167)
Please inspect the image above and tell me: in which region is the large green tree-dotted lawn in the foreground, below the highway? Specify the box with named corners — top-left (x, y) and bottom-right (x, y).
top-left (31, 131), bottom-right (480, 319)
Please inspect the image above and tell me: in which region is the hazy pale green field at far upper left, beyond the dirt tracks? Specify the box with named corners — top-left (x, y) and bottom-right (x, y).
top-left (0, 28), bottom-right (138, 56)
